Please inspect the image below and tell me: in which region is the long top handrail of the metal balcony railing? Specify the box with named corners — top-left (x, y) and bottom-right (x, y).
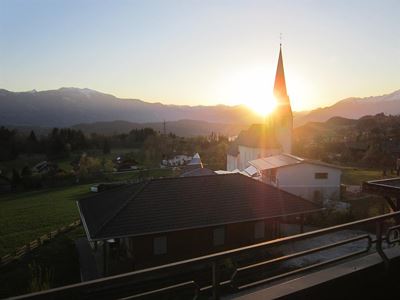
top-left (12, 211), bottom-right (400, 299)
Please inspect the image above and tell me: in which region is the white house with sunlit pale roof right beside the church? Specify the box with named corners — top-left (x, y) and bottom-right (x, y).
top-left (250, 154), bottom-right (342, 202)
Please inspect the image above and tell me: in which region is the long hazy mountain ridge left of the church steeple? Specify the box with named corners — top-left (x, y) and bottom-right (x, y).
top-left (0, 88), bottom-right (261, 127)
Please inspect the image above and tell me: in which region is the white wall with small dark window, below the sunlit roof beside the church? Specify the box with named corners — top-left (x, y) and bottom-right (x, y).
top-left (276, 163), bottom-right (342, 201)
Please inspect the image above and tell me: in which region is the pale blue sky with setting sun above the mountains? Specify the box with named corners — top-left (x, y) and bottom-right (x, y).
top-left (0, 0), bottom-right (400, 111)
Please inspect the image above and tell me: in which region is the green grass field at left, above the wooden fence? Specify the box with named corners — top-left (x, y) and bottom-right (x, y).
top-left (0, 185), bottom-right (90, 256)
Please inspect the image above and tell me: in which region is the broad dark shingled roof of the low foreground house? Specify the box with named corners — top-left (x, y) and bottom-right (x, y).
top-left (78, 174), bottom-right (320, 240)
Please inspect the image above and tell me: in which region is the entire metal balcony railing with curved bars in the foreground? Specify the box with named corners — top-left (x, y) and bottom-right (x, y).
top-left (10, 212), bottom-right (400, 299)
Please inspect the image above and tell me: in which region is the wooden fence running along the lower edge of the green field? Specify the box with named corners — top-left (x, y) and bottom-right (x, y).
top-left (0, 220), bottom-right (81, 267)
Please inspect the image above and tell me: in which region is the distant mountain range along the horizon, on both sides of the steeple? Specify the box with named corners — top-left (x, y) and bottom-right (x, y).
top-left (0, 88), bottom-right (400, 136)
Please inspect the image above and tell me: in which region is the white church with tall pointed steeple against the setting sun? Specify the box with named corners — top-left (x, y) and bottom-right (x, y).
top-left (226, 47), bottom-right (293, 171)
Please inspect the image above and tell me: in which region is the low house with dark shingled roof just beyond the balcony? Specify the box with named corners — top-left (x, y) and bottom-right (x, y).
top-left (78, 174), bottom-right (321, 275)
